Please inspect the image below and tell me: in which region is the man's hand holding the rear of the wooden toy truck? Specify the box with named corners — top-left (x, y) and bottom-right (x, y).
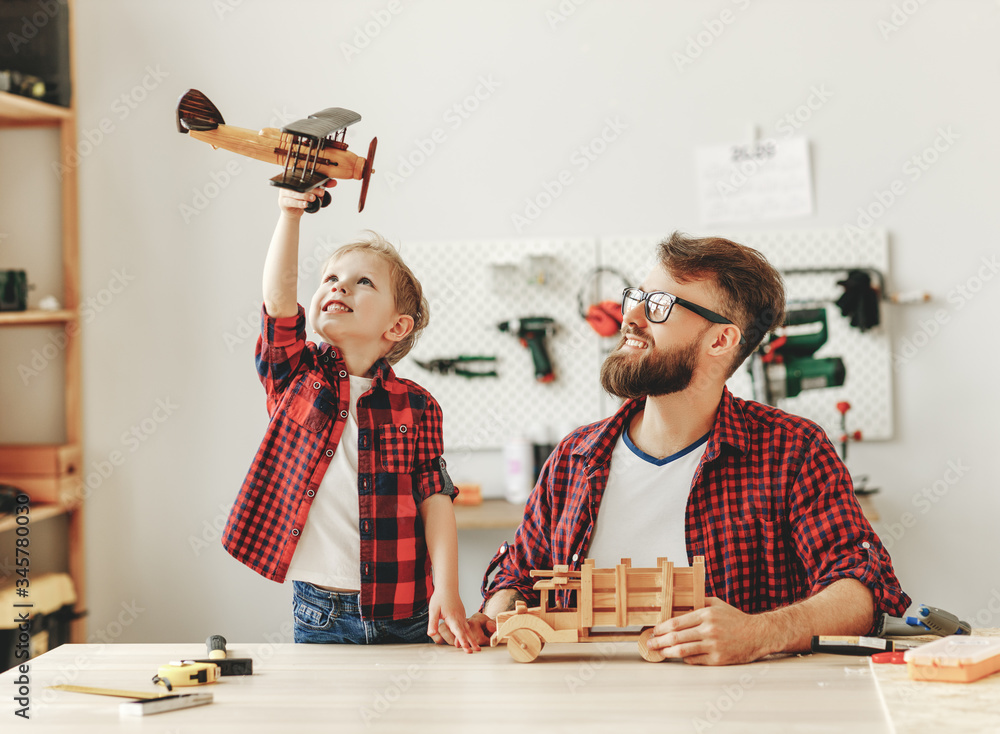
top-left (646, 597), bottom-right (781, 665)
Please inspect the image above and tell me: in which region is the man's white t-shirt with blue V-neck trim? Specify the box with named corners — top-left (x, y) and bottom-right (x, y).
top-left (587, 428), bottom-right (708, 568)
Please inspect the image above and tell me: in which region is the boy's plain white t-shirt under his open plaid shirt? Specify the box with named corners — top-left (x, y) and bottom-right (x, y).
top-left (286, 375), bottom-right (372, 591)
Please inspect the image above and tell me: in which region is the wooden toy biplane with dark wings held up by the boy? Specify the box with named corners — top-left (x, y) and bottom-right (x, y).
top-left (177, 89), bottom-right (378, 212)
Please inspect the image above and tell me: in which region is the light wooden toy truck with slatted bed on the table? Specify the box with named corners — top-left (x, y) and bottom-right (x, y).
top-left (490, 556), bottom-right (705, 663)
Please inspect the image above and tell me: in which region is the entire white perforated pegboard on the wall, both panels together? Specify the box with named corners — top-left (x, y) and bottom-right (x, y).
top-left (396, 230), bottom-right (893, 451)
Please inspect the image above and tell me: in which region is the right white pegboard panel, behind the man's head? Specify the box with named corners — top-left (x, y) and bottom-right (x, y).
top-left (601, 229), bottom-right (893, 441)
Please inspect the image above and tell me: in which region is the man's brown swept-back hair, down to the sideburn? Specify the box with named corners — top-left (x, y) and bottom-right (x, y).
top-left (658, 232), bottom-right (785, 375)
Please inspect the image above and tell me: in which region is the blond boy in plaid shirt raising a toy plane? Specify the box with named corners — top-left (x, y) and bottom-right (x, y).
top-left (223, 181), bottom-right (479, 652)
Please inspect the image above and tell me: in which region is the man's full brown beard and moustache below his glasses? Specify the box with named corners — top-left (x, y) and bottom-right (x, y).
top-left (601, 336), bottom-right (699, 400)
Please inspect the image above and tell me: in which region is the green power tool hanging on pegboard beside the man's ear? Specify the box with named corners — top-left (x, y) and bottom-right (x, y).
top-left (750, 308), bottom-right (846, 405)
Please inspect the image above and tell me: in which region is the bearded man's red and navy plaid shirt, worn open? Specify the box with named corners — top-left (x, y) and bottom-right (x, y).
top-left (483, 389), bottom-right (910, 624)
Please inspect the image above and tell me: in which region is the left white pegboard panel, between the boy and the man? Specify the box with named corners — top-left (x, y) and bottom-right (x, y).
top-left (395, 239), bottom-right (603, 451)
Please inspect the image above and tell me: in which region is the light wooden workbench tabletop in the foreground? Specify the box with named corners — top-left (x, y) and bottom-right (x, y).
top-left (0, 643), bottom-right (1000, 734)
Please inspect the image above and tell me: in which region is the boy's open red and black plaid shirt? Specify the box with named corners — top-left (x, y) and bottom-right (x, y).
top-left (222, 306), bottom-right (455, 619)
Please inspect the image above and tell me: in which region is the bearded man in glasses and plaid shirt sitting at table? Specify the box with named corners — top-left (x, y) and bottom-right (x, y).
top-left (458, 233), bottom-right (910, 665)
